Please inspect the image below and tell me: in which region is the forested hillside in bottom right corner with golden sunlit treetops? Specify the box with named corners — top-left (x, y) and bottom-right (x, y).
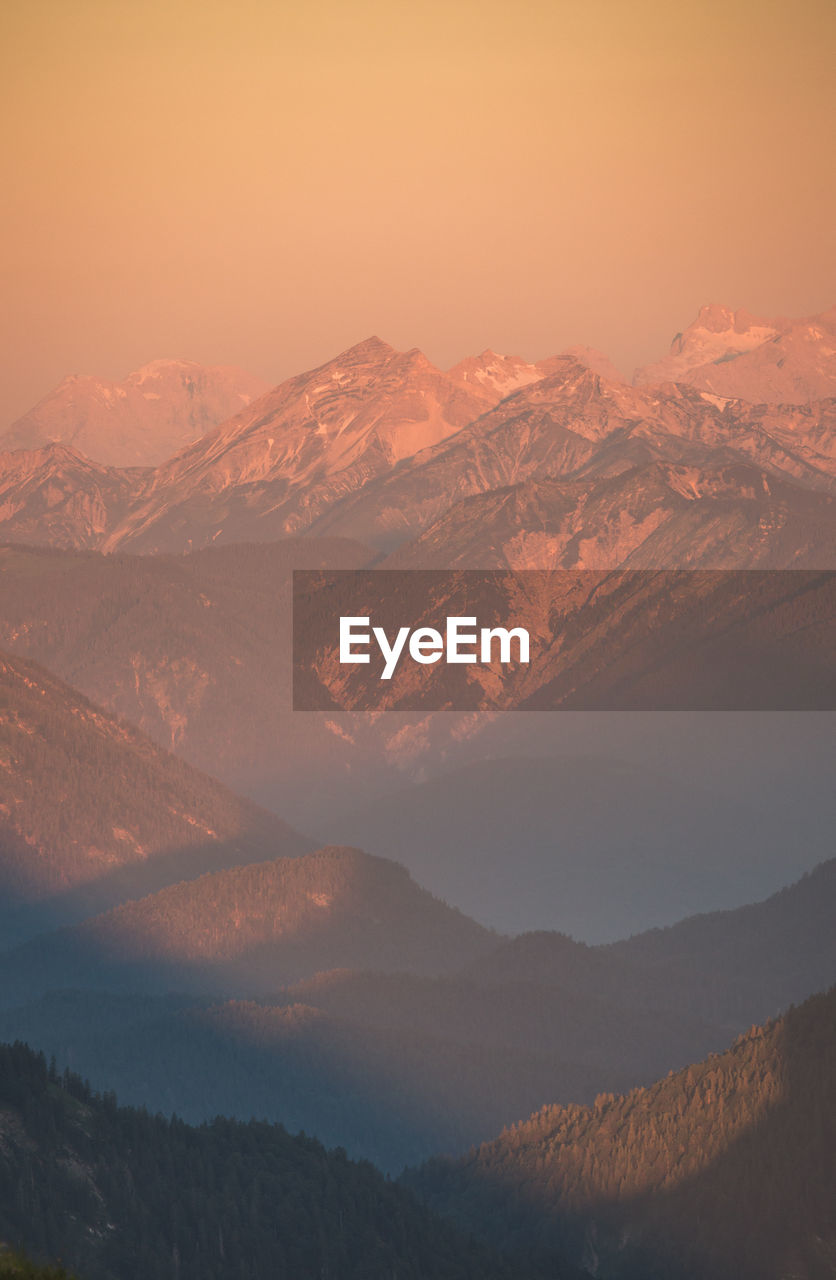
top-left (407, 988), bottom-right (836, 1280)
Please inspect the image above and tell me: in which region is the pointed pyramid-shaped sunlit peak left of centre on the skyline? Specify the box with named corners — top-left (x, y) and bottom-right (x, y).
top-left (101, 337), bottom-right (499, 550)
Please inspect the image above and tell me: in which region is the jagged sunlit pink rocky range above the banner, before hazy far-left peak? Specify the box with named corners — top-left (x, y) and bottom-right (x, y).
top-left (0, 307), bottom-right (836, 567)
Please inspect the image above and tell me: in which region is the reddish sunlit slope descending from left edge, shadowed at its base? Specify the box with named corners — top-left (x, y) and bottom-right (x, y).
top-left (0, 654), bottom-right (311, 946)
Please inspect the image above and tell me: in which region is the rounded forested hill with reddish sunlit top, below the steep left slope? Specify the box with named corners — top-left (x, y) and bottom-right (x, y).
top-left (0, 847), bottom-right (498, 1006)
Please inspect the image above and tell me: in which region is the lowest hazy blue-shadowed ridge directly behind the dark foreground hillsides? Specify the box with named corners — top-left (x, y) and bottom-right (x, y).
top-left (0, 977), bottom-right (617, 1174)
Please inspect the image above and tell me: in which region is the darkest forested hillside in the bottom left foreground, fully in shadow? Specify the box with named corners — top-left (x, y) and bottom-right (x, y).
top-left (0, 1044), bottom-right (576, 1280)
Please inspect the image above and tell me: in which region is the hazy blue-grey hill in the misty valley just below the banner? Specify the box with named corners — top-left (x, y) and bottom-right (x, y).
top-left (322, 742), bottom-right (836, 941)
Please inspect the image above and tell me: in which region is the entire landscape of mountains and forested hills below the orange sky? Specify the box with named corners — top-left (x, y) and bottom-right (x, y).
top-left (0, 306), bottom-right (836, 1280)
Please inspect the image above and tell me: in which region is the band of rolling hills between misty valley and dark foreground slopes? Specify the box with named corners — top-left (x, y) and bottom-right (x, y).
top-left (0, 850), bottom-right (836, 1169)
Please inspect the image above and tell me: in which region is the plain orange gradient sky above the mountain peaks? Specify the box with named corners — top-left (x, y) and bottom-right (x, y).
top-left (0, 0), bottom-right (836, 426)
